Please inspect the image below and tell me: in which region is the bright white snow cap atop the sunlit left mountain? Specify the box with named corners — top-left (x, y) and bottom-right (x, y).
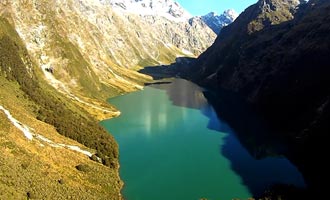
top-left (100, 0), bottom-right (192, 21)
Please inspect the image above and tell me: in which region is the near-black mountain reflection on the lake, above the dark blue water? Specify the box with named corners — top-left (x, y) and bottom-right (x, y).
top-left (204, 91), bottom-right (286, 159)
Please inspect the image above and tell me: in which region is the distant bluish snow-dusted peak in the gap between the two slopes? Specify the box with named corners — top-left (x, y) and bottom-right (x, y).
top-left (201, 10), bottom-right (238, 34)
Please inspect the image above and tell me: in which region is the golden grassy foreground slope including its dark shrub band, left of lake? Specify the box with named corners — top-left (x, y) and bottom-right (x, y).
top-left (0, 18), bottom-right (121, 199)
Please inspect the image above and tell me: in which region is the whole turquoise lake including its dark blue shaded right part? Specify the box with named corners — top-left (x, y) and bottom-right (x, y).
top-left (101, 79), bottom-right (304, 200)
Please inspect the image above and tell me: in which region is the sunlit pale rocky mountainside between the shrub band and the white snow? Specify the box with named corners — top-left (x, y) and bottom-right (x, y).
top-left (0, 0), bottom-right (215, 118)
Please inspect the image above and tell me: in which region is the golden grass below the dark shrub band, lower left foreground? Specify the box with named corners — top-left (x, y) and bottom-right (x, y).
top-left (0, 76), bottom-right (122, 199)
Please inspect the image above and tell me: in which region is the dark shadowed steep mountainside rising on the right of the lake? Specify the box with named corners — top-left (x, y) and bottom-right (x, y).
top-left (184, 0), bottom-right (330, 196)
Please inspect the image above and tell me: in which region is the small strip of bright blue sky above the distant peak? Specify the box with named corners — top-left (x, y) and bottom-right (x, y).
top-left (176, 0), bottom-right (257, 16)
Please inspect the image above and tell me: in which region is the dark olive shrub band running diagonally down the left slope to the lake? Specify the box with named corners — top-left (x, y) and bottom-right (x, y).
top-left (0, 18), bottom-right (118, 167)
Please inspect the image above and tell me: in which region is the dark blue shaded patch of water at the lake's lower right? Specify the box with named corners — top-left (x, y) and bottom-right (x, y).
top-left (220, 134), bottom-right (305, 195)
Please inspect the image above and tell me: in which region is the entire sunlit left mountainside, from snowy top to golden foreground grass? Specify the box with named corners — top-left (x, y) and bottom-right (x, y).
top-left (0, 0), bottom-right (216, 200)
